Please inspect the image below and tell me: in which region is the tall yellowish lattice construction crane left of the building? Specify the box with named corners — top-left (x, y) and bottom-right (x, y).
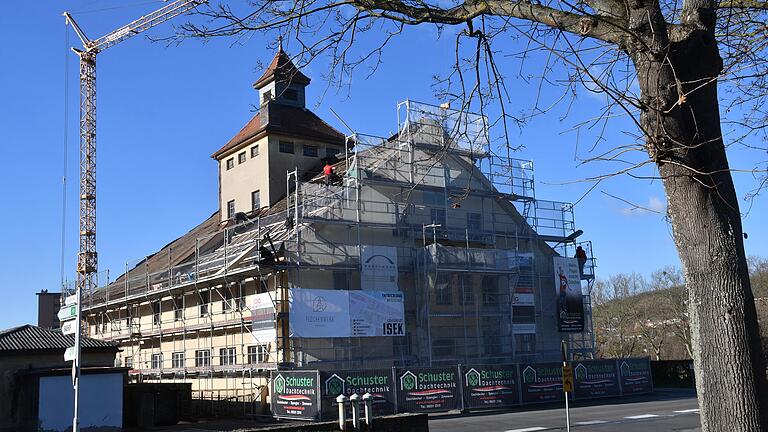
top-left (64, 0), bottom-right (207, 432)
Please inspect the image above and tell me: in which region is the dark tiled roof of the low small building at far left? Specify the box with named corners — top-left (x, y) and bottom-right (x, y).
top-left (0, 324), bottom-right (118, 354)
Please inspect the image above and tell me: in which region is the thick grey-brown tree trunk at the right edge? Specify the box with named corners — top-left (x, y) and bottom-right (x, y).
top-left (630, 22), bottom-right (768, 432)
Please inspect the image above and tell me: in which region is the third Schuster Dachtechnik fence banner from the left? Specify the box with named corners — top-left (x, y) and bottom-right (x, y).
top-left (395, 366), bottom-right (460, 412)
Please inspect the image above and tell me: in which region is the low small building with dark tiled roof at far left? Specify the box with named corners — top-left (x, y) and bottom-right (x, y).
top-left (0, 324), bottom-right (125, 432)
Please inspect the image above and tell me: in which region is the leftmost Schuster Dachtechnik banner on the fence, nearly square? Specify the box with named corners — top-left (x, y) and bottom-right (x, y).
top-left (270, 371), bottom-right (320, 420)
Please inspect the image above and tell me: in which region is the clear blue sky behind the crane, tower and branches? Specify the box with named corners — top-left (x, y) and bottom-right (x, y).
top-left (0, 0), bottom-right (768, 328)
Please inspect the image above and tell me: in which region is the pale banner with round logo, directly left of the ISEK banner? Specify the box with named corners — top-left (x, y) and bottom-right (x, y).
top-left (288, 288), bottom-right (352, 338)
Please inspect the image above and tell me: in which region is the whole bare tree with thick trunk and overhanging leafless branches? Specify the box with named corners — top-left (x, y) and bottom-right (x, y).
top-left (174, 0), bottom-right (768, 426)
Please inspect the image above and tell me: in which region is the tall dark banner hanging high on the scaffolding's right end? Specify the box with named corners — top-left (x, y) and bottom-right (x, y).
top-left (552, 257), bottom-right (584, 333)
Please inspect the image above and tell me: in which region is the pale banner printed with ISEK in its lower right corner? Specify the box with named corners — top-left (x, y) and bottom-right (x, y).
top-left (349, 291), bottom-right (405, 336)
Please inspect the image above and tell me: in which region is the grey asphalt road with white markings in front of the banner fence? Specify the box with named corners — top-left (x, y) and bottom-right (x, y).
top-left (429, 391), bottom-right (701, 432)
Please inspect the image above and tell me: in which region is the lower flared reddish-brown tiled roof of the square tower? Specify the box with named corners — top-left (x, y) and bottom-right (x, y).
top-left (211, 102), bottom-right (345, 159)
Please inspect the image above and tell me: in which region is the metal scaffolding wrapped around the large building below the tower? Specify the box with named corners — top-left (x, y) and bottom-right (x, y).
top-left (72, 101), bottom-right (594, 401)
